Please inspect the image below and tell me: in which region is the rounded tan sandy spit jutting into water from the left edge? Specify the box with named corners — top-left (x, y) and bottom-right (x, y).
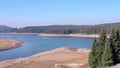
top-left (0, 39), bottom-right (22, 51)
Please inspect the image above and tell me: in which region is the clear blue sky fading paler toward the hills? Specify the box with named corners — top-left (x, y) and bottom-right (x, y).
top-left (0, 0), bottom-right (120, 27)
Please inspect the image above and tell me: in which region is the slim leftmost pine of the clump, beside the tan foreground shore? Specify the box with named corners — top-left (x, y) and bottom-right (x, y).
top-left (89, 38), bottom-right (97, 68)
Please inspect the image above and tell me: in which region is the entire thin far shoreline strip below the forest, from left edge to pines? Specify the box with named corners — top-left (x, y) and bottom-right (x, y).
top-left (0, 32), bottom-right (110, 38)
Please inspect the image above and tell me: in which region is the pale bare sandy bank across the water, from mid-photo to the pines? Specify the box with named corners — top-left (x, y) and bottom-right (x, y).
top-left (39, 33), bottom-right (109, 38)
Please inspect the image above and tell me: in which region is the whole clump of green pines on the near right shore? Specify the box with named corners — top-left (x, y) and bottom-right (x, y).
top-left (89, 29), bottom-right (120, 68)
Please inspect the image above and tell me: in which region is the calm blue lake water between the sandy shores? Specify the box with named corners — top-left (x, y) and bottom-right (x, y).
top-left (0, 34), bottom-right (93, 60)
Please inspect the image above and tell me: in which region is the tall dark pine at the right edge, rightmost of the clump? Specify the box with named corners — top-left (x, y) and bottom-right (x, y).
top-left (110, 29), bottom-right (120, 64)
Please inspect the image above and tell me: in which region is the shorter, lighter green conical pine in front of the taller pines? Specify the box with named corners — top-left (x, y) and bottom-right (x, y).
top-left (102, 41), bottom-right (113, 67)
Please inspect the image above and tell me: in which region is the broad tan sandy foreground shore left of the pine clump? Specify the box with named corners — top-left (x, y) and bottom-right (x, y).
top-left (0, 47), bottom-right (90, 68)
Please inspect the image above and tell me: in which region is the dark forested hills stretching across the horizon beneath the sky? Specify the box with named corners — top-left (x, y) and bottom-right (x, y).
top-left (0, 22), bottom-right (120, 34)
